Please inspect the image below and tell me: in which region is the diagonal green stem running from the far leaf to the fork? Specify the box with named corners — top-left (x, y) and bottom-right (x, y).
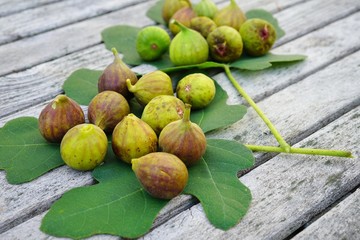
top-left (223, 64), bottom-right (291, 153)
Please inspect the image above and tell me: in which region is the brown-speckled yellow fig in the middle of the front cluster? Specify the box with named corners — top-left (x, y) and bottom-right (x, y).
top-left (141, 95), bottom-right (185, 134)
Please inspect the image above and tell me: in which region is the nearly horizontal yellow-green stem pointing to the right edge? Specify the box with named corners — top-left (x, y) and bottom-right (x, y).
top-left (245, 144), bottom-right (353, 158)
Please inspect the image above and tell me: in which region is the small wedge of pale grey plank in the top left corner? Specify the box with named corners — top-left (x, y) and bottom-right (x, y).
top-left (0, 0), bottom-right (60, 17)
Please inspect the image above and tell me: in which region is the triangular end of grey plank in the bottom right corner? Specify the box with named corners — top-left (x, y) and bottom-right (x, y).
top-left (293, 189), bottom-right (360, 240)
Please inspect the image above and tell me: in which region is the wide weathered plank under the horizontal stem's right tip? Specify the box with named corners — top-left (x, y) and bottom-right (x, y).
top-left (140, 107), bottom-right (360, 240)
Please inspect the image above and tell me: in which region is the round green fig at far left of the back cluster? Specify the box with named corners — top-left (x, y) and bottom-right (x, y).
top-left (136, 26), bottom-right (171, 61)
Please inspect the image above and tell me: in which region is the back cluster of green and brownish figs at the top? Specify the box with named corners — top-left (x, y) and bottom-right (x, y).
top-left (137, 0), bottom-right (276, 65)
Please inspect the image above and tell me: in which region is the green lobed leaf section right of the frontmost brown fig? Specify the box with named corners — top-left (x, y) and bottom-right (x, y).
top-left (184, 139), bottom-right (254, 230)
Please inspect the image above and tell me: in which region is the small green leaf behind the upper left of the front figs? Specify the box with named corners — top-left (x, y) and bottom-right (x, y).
top-left (63, 68), bottom-right (102, 105)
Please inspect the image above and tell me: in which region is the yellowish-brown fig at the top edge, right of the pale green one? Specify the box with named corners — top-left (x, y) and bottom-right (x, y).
top-left (213, 0), bottom-right (246, 31)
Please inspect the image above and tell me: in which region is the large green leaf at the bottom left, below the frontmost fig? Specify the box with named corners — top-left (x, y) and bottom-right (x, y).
top-left (40, 154), bottom-right (168, 239)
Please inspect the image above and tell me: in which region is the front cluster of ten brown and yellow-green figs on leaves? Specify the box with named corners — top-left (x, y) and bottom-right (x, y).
top-left (39, 48), bottom-right (216, 199)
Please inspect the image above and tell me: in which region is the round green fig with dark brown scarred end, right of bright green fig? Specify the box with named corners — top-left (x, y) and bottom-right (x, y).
top-left (207, 26), bottom-right (243, 62)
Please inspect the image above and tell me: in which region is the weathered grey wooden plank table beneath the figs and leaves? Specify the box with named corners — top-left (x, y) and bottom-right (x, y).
top-left (0, 0), bottom-right (360, 240)
